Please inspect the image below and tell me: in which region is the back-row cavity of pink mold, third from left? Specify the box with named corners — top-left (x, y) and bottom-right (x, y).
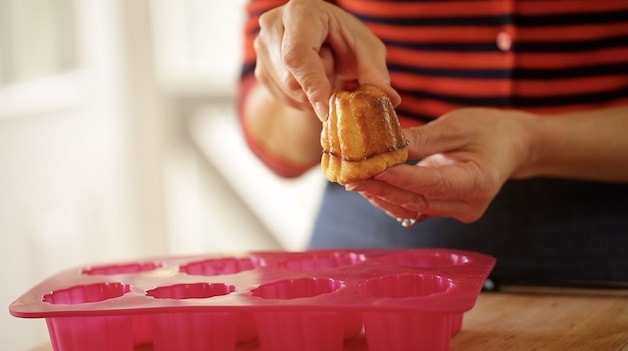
top-left (279, 251), bottom-right (366, 271)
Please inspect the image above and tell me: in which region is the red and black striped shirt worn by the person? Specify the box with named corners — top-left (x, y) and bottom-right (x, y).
top-left (241, 0), bottom-right (628, 175)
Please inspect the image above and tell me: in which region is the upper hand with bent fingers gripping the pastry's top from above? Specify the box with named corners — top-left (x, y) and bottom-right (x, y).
top-left (255, 0), bottom-right (400, 120)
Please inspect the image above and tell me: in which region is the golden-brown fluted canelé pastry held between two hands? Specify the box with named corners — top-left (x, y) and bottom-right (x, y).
top-left (321, 85), bottom-right (408, 184)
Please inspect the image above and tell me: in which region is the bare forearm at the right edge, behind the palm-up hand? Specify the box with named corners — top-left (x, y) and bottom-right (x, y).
top-left (512, 106), bottom-right (628, 182)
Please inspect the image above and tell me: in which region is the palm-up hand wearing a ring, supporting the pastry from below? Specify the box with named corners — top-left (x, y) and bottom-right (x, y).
top-left (346, 108), bottom-right (532, 222)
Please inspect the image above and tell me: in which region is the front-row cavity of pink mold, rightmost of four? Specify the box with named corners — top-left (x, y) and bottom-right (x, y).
top-left (361, 273), bottom-right (452, 298)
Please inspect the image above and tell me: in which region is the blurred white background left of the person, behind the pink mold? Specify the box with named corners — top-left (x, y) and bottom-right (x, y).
top-left (0, 0), bottom-right (324, 351)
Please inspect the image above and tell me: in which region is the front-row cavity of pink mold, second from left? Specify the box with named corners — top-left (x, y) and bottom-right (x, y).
top-left (146, 283), bottom-right (235, 299)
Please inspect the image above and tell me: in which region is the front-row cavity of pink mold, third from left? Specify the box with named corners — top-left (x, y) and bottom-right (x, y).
top-left (251, 277), bottom-right (344, 300)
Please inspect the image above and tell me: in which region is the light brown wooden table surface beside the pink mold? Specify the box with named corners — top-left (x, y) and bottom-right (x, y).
top-left (30, 287), bottom-right (628, 351)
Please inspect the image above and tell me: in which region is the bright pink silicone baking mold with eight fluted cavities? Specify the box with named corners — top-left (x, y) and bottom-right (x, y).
top-left (9, 249), bottom-right (495, 351)
